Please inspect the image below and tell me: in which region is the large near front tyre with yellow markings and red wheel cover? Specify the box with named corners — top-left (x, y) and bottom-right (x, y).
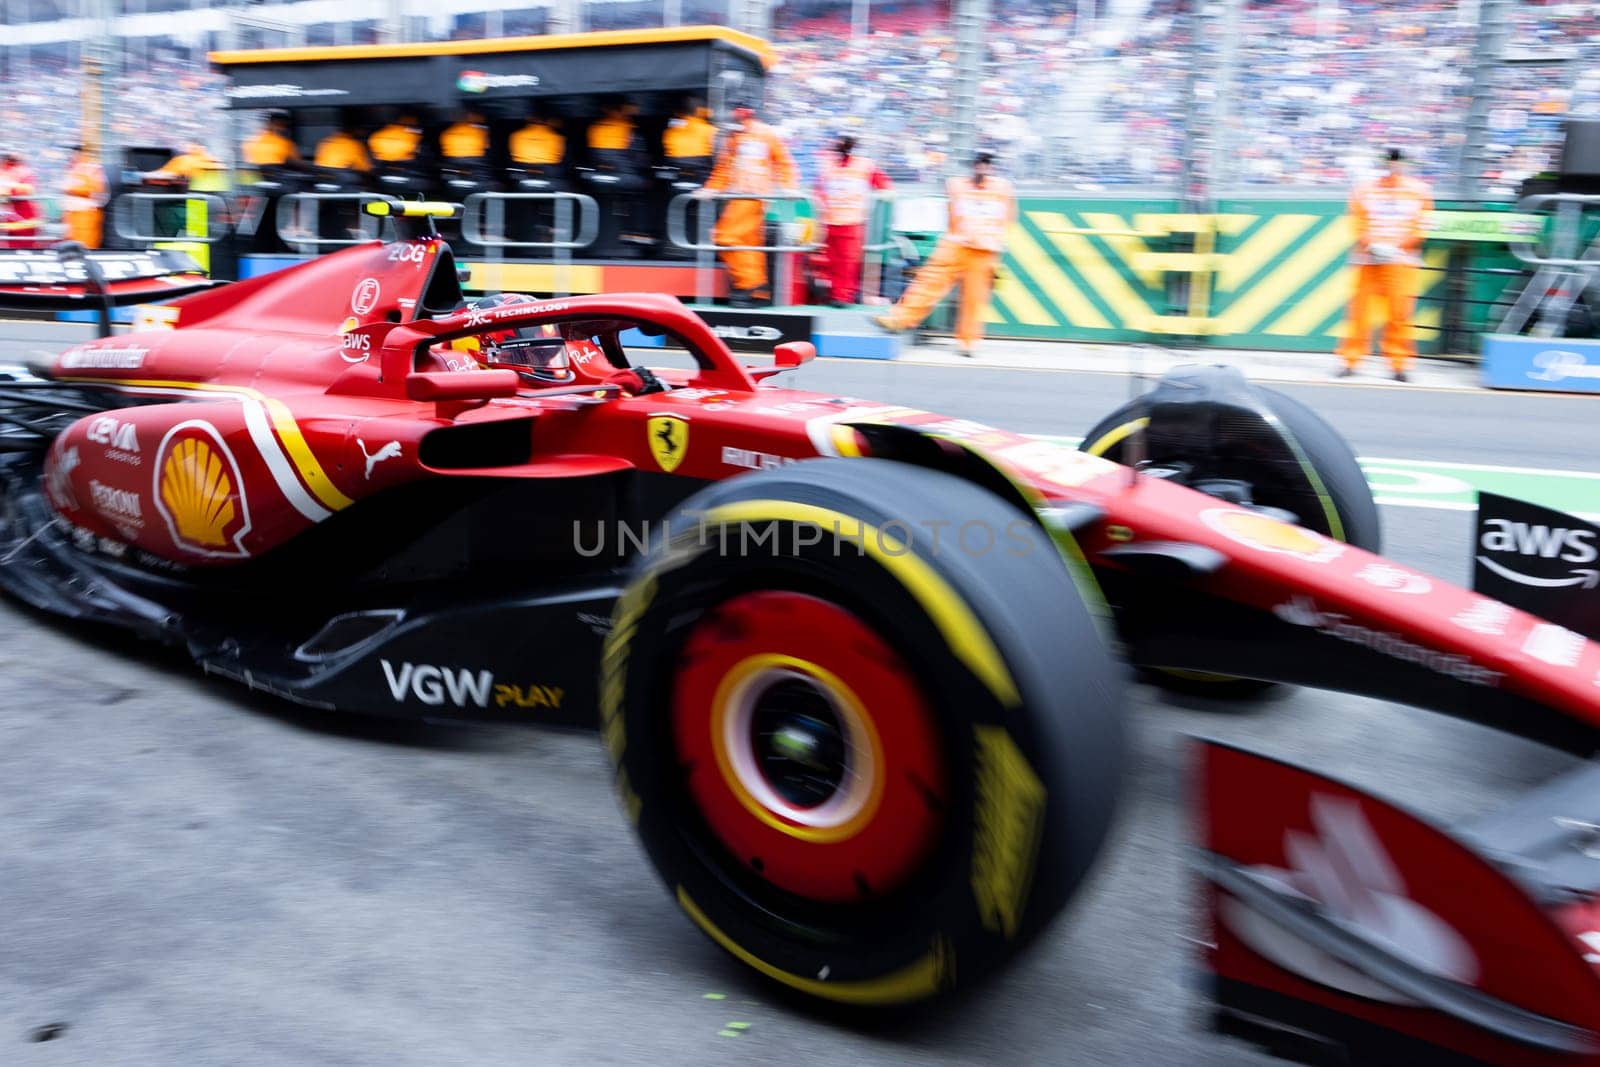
top-left (600, 459), bottom-right (1125, 1008)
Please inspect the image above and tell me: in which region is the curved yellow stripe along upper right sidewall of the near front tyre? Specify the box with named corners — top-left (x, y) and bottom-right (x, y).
top-left (706, 501), bottom-right (1022, 707)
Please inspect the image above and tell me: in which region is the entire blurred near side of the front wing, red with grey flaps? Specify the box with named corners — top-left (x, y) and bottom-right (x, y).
top-left (1197, 742), bottom-right (1600, 1067)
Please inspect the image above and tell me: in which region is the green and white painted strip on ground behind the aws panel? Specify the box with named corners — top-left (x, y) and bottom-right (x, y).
top-left (1040, 435), bottom-right (1600, 520)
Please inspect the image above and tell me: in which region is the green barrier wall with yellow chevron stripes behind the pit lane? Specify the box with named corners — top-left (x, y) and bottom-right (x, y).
top-left (989, 198), bottom-right (1510, 352)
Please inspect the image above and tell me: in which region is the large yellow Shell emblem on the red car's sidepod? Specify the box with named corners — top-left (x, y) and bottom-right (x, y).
top-left (152, 419), bottom-right (250, 557)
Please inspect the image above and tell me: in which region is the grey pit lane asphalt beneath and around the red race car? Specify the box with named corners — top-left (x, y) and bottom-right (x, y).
top-left (0, 326), bottom-right (1600, 1067)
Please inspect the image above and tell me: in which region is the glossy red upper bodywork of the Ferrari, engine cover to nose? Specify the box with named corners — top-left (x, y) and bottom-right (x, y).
top-left (45, 238), bottom-right (1600, 748)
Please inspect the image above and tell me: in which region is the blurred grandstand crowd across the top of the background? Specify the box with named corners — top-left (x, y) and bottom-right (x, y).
top-left (0, 0), bottom-right (1600, 198)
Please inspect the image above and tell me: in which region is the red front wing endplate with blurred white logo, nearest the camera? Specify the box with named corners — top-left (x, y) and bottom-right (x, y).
top-left (1195, 742), bottom-right (1600, 1067)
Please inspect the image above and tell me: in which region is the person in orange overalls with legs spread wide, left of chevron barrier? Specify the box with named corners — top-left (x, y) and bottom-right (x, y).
top-left (872, 152), bottom-right (1016, 358)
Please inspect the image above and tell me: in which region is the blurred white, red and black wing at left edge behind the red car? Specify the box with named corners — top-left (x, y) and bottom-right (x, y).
top-left (0, 242), bottom-right (219, 338)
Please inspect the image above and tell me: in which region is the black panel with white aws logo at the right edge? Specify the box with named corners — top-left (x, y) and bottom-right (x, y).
top-left (1472, 493), bottom-right (1600, 640)
